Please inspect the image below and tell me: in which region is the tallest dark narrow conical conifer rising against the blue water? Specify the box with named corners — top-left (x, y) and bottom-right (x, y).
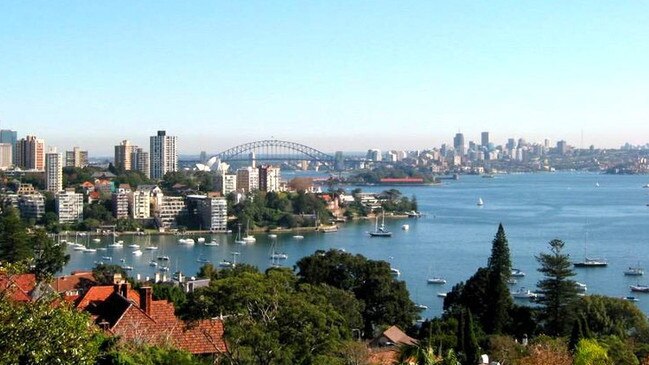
top-left (483, 224), bottom-right (512, 333)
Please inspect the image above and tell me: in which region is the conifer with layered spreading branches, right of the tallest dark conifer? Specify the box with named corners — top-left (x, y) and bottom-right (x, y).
top-left (536, 239), bottom-right (579, 335)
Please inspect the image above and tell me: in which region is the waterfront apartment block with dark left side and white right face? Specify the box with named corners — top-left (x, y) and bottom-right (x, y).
top-left (187, 195), bottom-right (228, 232)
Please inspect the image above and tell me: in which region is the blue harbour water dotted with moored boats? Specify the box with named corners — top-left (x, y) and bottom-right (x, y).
top-left (65, 173), bottom-right (649, 317)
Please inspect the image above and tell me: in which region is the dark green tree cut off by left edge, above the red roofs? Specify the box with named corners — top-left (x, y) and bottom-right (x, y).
top-left (0, 207), bottom-right (33, 262)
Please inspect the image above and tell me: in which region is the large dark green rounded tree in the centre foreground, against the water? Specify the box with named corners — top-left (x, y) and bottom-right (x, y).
top-left (296, 250), bottom-right (418, 336)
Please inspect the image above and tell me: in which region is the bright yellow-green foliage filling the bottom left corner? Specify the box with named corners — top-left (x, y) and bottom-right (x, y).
top-left (0, 298), bottom-right (100, 364)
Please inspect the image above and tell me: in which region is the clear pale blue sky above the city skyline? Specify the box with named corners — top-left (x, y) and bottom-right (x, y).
top-left (0, 0), bottom-right (649, 155)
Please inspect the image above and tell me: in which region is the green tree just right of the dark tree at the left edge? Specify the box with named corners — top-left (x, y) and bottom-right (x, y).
top-left (30, 229), bottom-right (70, 281)
